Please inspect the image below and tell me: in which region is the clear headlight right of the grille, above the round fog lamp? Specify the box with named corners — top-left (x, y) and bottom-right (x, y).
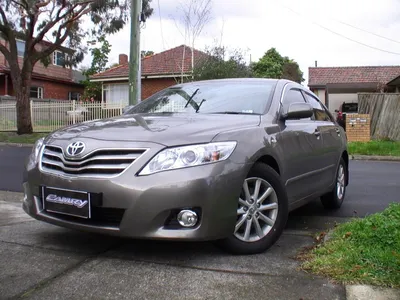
top-left (139, 142), bottom-right (236, 175)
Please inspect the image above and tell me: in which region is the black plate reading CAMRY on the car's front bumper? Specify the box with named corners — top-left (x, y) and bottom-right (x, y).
top-left (42, 186), bottom-right (91, 219)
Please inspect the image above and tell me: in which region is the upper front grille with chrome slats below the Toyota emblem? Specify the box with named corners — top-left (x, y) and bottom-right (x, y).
top-left (41, 146), bottom-right (145, 177)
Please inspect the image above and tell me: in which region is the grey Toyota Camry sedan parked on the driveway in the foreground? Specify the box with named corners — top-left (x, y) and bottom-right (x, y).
top-left (23, 79), bottom-right (349, 254)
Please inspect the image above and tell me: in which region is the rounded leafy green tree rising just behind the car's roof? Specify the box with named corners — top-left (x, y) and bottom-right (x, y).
top-left (252, 48), bottom-right (304, 83)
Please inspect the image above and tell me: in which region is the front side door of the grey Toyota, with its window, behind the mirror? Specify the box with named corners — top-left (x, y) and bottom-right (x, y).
top-left (276, 87), bottom-right (323, 202)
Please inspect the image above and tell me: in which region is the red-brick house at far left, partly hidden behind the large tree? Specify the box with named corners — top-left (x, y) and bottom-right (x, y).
top-left (0, 38), bottom-right (84, 100)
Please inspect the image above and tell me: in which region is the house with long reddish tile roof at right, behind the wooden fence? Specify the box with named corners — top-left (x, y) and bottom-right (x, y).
top-left (308, 66), bottom-right (400, 112)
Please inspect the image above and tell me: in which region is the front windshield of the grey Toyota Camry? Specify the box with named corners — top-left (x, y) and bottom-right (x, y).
top-left (126, 81), bottom-right (276, 114)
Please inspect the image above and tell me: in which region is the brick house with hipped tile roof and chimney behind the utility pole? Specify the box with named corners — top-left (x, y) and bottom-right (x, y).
top-left (91, 45), bottom-right (206, 105)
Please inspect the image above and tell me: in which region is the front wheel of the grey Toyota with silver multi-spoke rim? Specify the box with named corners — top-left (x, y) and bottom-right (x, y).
top-left (216, 163), bottom-right (288, 254)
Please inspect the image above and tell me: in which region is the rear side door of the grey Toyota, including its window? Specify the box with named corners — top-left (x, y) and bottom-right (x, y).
top-left (303, 91), bottom-right (343, 189)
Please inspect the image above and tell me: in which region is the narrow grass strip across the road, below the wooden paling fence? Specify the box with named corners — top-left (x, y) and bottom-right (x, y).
top-left (348, 141), bottom-right (400, 156)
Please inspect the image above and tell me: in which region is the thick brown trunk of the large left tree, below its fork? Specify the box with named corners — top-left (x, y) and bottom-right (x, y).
top-left (13, 71), bottom-right (33, 134)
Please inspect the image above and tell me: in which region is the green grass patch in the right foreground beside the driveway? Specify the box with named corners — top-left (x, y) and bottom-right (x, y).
top-left (299, 203), bottom-right (400, 288)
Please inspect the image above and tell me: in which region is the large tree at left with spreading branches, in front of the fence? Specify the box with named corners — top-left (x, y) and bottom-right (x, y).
top-left (0, 0), bottom-right (153, 134)
